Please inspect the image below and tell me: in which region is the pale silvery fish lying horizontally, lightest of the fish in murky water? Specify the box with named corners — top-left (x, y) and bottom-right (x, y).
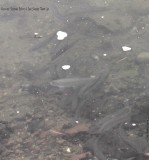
top-left (50, 77), bottom-right (95, 88)
